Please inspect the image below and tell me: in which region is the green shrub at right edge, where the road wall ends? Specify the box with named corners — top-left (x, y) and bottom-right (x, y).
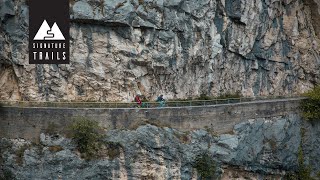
top-left (301, 86), bottom-right (320, 120)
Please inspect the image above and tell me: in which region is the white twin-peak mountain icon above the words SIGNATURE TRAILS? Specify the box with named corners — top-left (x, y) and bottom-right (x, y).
top-left (33, 20), bottom-right (65, 40)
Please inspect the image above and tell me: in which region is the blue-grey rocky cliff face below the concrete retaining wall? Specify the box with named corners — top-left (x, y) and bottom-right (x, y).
top-left (0, 114), bottom-right (320, 180)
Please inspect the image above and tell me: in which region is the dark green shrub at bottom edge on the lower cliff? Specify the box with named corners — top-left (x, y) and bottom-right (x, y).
top-left (193, 152), bottom-right (216, 179)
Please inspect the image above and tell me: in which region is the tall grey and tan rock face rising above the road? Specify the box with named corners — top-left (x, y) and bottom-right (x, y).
top-left (0, 0), bottom-right (320, 101)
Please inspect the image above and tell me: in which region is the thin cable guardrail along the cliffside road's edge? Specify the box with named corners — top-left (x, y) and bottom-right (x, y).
top-left (0, 96), bottom-right (301, 109)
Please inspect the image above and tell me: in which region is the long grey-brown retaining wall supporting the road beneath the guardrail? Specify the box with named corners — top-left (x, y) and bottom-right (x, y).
top-left (0, 98), bottom-right (301, 140)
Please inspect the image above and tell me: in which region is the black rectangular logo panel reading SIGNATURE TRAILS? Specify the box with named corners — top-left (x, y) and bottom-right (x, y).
top-left (29, 0), bottom-right (70, 64)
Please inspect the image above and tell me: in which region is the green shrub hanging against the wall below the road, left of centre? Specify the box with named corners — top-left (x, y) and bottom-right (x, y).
top-left (71, 118), bottom-right (102, 159)
